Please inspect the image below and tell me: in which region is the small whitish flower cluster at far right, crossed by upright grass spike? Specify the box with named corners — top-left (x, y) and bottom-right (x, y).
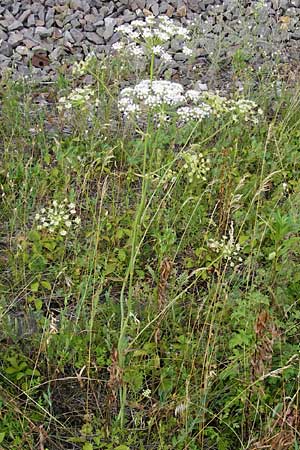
top-left (208, 222), bottom-right (243, 267)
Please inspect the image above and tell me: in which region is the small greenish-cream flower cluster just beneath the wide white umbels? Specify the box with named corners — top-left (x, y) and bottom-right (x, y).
top-left (182, 145), bottom-right (210, 183)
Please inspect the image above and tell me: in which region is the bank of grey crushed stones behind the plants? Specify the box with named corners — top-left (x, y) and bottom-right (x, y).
top-left (0, 0), bottom-right (300, 79)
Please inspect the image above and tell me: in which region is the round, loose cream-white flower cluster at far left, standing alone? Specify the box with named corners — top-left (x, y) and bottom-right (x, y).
top-left (35, 198), bottom-right (81, 236)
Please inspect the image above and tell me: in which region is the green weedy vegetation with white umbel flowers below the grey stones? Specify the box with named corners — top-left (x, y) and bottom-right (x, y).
top-left (0, 17), bottom-right (300, 450)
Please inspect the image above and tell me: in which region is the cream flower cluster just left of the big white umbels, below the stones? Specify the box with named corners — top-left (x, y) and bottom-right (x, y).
top-left (58, 86), bottom-right (99, 111)
